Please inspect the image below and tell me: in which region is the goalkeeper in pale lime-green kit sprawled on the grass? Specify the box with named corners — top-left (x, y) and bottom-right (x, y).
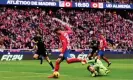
top-left (87, 59), bottom-right (109, 77)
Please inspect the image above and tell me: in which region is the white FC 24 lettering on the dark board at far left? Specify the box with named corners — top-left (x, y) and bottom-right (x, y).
top-left (1, 52), bottom-right (23, 61)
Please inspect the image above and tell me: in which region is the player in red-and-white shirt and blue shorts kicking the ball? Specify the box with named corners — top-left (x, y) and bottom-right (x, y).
top-left (48, 26), bottom-right (87, 78)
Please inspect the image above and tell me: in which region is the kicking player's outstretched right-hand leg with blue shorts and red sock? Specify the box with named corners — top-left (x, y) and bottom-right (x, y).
top-left (64, 50), bottom-right (87, 64)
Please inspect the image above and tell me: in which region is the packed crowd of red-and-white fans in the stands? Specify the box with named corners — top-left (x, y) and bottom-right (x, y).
top-left (0, 7), bottom-right (133, 49)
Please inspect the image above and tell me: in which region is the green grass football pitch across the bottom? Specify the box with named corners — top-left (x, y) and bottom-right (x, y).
top-left (0, 59), bottom-right (133, 80)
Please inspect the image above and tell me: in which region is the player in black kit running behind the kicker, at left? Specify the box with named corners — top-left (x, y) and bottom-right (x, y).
top-left (32, 34), bottom-right (54, 70)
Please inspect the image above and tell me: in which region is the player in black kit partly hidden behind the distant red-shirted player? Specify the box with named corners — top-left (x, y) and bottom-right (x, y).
top-left (88, 36), bottom-right (100, 60)
